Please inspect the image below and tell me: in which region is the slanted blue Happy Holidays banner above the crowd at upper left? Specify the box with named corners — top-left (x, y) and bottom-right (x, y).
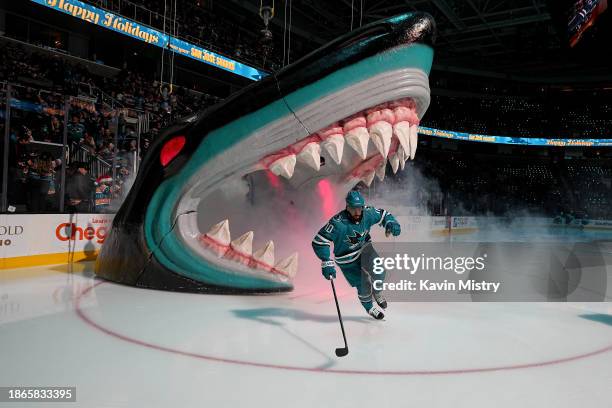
top-left (31, 0), bottom-right (267, 81)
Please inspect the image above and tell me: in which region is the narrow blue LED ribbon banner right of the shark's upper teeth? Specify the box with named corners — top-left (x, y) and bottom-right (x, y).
top-left (419, 126), bottom-right (612, 147)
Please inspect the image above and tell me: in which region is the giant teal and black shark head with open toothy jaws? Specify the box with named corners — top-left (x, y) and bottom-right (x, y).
top-left (96, 12), bottom-right (435, 293)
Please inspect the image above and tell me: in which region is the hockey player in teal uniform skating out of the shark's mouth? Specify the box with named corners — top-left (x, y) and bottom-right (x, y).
top-left (312, 191), bottom-right (401, 320)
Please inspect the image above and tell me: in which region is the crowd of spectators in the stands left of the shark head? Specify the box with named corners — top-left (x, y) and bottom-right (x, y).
top-left (0, 41), bottom-right (227, 211)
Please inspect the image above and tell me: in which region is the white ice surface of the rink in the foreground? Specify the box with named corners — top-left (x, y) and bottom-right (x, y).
top-left (0, 264), bottom-right (612, 408)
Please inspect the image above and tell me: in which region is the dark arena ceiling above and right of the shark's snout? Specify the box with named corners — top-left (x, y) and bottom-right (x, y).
top-left (224, 0), bottom-right (612, 82)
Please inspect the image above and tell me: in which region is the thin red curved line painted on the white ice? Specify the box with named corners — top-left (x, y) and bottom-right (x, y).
top-left (75, 282), bottom-right (612, 375)
